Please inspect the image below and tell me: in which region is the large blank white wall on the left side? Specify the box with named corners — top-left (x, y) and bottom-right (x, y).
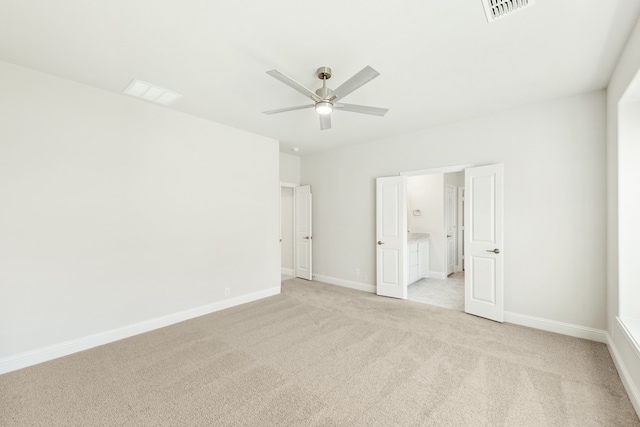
top-left (0, 62), bottom-right (280, 361)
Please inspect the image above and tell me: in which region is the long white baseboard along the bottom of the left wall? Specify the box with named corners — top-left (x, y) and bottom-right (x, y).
top-left (0, 286), bottom-right (280, 374)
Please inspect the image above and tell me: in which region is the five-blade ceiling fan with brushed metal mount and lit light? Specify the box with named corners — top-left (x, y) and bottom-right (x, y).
top-left (263, 65), bottom-right (389, 130)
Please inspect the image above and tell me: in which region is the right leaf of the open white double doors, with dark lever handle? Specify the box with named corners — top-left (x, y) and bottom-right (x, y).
top-left (464, 164), bottom-right (504, 322)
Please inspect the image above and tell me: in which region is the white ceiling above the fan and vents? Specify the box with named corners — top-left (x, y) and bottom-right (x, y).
top-left (0, 0), bottom-right (640, 155)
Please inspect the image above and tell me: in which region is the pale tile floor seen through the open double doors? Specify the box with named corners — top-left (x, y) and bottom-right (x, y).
top-left (407, 271), bottom-right (464, 311)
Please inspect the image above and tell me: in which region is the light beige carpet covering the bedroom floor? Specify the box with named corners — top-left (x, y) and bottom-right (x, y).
top-left (0, 279), bottom-right (640, 427)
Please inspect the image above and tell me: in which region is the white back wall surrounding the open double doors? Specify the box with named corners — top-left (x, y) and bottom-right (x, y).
top-left (302, 91), bottom-right (606, 329)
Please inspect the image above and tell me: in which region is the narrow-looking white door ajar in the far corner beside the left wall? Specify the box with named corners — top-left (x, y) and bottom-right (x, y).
top-left (295, 185), bottom-right (313, 280)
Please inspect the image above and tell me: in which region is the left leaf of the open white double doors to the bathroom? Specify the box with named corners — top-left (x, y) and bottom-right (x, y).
top-left (376, 176), bottom-right (407, 299)
